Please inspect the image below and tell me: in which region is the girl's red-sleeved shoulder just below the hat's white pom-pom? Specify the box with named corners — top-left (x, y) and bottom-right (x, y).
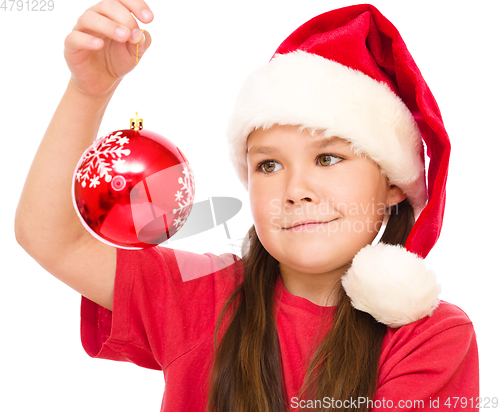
top-left (379, 301), bottom-right (479, 399)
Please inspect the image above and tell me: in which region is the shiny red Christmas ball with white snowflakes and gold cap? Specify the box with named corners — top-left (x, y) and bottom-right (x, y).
top-left (72, 117), bottom-right (194, 249)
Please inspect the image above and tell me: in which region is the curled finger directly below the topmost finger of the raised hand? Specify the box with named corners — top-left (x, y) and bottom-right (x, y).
top-left (74, 9), bottom-right (131, 43)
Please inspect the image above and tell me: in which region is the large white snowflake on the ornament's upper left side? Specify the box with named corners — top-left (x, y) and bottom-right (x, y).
top-left (76, 132), bottom-right (130, 188)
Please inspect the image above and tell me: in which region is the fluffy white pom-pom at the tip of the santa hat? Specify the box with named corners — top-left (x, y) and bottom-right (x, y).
top-left (342, 243), bottom-right (441, 328)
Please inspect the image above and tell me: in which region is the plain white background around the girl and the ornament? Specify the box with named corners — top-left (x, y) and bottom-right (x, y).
top-left (0, 0), bottom-right (500, 412)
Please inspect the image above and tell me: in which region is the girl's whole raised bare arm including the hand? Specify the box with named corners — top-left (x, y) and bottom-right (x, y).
top-left (15, 0), bottom-right (153, 309)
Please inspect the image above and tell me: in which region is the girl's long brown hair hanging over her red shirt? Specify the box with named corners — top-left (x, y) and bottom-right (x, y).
top-left (207, 199), bottom-right (415, 412)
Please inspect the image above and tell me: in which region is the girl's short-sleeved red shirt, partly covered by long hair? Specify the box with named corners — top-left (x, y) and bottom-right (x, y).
top-left (81, 247), bottom-right (479, 412)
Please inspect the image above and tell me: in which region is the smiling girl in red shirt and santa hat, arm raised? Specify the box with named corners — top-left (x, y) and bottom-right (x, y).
top-left (16, 0), bottom-right (478, 412)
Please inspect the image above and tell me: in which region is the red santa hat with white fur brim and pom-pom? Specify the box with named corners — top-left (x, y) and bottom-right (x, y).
top-left (228, 5), bottom-right (450, 327)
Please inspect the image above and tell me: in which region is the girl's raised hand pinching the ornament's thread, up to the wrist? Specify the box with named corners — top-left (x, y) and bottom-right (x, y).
top-left (64, 0), bottom-right (153, 96)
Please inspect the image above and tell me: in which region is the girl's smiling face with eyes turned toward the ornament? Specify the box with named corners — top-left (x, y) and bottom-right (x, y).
top-left (247, 122), bottom-right (405, 273)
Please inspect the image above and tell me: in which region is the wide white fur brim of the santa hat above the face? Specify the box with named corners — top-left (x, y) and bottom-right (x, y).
top-left (228, 51), bottom-right (427, 216)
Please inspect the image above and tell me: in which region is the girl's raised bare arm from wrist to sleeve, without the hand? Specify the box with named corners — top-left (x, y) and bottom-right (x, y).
top-left (16, 81), bottom-right (116, 308)
